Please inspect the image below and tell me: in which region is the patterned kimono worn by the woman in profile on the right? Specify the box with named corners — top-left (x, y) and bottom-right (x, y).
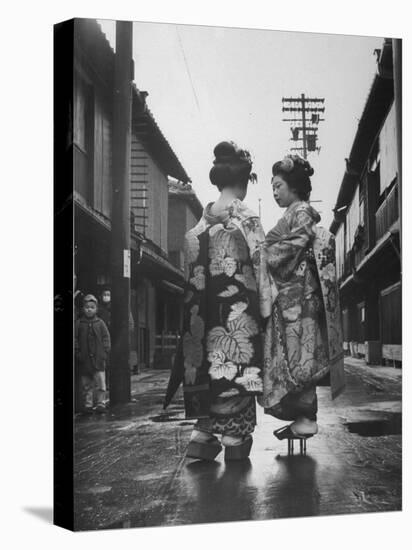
top-left (261, 201), bottom-right (344, 417)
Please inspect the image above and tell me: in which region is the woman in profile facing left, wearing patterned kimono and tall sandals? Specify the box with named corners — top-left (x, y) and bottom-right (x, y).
top-left (260, 155), bottom-right (344, 439)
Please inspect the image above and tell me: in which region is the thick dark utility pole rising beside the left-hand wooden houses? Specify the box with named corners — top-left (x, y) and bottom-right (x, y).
top-left (110, 21), bottom-right (133, 405)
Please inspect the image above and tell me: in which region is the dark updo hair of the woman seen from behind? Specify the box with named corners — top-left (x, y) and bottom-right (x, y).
top-left (209, 141), bottom-right (257, 191)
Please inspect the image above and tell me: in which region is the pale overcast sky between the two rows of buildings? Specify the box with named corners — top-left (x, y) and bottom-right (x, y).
top-left (99, 21), bottom-right (383, 231)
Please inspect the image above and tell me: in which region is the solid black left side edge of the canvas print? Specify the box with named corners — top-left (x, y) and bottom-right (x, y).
top-left (53, 19), bottom-right (75, 531)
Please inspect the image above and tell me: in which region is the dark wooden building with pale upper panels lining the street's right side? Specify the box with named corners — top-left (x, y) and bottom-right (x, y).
top-left (331, 39), bottom-right (402, 364)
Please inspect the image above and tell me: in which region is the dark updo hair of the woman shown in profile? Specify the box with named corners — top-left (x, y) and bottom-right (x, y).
top-left (272, 155), bottom-right (314, 201)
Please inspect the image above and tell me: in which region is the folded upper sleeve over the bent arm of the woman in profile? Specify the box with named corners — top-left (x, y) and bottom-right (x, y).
top-left (265, 206), bottom-right (316, 279)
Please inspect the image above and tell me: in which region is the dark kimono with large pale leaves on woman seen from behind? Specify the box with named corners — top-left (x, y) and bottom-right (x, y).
top-left (182, 200), bottom-right (271, 435)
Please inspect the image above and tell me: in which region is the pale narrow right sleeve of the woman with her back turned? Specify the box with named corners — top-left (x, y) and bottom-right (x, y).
top-left (242, 217), bottom-right (277, 319)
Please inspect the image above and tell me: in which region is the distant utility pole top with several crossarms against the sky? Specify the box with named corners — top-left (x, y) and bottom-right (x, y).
top-left (282, 94), bottom-right (325, 159)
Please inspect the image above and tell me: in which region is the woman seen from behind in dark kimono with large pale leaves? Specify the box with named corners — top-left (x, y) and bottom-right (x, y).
top-left (166, 142), bottom-right (272, 460)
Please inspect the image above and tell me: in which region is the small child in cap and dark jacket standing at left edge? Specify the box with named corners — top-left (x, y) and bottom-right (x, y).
top-left (75, 294), bottom-right (110, 414)
